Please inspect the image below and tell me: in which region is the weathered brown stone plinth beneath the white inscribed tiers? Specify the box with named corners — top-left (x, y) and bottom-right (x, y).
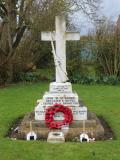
top-left (18, 112), bottom-right (104, 141)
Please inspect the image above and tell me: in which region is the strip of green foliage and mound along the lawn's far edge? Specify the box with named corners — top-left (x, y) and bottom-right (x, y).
top-left (14, 69), bottom-right (120, 85)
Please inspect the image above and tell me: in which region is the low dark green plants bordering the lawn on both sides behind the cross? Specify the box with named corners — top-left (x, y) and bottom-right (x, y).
top-left (17, 72), bottom-right (120, 85)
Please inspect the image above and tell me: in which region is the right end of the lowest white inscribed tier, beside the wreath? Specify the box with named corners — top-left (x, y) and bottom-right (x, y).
top-left (72, 107), bottom-right (87, 121)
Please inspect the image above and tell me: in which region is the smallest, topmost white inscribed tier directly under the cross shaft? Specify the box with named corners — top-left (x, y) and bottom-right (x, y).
top-left (50, 82), bottom-right (72, 93)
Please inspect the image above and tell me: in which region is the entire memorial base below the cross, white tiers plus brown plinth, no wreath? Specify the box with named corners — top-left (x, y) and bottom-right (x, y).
top-left (13, 82), bottom-right (104, 143)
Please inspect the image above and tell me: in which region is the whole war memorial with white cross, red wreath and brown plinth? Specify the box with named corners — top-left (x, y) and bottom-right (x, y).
top-left (10, 16), bottom-right (105, 143)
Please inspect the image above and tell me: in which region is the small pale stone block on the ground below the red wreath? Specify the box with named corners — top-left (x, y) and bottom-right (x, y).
top-left (47, 132), bottom-right (65, 143)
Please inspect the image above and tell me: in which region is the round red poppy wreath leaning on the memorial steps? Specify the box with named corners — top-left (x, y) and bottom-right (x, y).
top-left (45, 104), bottom-right (73, 129)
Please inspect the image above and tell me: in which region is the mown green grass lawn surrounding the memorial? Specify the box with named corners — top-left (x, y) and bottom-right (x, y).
top-left (0, 82), bottom-right (120, 160)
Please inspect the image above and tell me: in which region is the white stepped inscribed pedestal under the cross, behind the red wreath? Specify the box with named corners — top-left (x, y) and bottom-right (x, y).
top-left (35, 82), bottom-right (87, 121)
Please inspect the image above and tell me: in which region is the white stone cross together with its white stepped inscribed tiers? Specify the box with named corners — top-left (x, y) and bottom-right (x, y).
top-left (35, 16), bottom-right (87, 120)
